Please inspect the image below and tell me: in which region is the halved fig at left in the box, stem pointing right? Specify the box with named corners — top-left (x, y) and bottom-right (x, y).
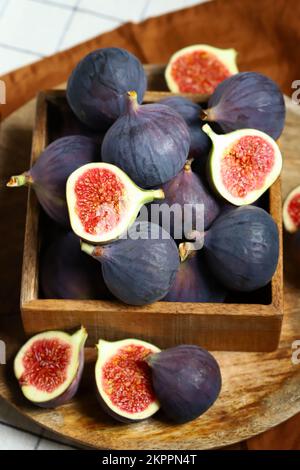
top-left (67, 163), bottom-right (164, 244)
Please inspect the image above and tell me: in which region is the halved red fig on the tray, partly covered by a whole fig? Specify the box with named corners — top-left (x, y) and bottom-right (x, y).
top-left (95, 339), bottom-right (160, 422)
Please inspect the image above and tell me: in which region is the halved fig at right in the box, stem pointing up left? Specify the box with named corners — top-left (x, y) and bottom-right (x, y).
top-left (202, 124), bottom-right (282, 206)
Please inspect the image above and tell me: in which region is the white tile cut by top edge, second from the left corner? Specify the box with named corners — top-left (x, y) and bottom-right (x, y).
top-left (79, 0), bottom-right (146, 21)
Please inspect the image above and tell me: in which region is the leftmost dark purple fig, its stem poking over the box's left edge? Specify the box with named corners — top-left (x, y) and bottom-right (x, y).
top-left (7, 135), bottom-right (100, 227)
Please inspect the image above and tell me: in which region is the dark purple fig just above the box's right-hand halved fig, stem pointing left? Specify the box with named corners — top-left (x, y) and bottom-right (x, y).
top-left (202, 72), bottom-right (285, 140)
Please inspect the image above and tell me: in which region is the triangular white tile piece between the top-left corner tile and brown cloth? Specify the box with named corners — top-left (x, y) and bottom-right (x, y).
top-left (59, 11), bottom-right (121, 50)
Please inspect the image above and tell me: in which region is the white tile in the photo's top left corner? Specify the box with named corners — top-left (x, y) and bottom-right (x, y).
top-left (0, 0), bottom-right (72, 55)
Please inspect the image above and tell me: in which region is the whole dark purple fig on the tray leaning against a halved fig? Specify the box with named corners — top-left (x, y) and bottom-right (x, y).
top-left (147, 345), bottom-right (222, 423)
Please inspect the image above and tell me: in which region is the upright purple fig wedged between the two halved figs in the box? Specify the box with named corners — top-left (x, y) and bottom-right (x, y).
top-left (157, 161), bottom-right (221, 239)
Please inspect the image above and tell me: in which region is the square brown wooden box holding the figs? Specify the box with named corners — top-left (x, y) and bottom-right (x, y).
top-left (21, 67), bottom-right (283, 351)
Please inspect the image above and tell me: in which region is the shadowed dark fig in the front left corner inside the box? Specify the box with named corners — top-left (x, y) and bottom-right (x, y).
top-left (40, 232), bottom-right (110, 300)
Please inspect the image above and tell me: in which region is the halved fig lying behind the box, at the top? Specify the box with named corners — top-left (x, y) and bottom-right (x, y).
top-left (165, 44), bottom-right (238, 94)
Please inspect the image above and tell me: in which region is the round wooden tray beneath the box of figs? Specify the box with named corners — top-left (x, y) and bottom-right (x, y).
top-left (0, 94), bottom-right (300, 449)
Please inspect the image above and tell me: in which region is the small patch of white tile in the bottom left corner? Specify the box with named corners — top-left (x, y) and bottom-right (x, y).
top-left (0, 424), bottom-right (39, 450)
